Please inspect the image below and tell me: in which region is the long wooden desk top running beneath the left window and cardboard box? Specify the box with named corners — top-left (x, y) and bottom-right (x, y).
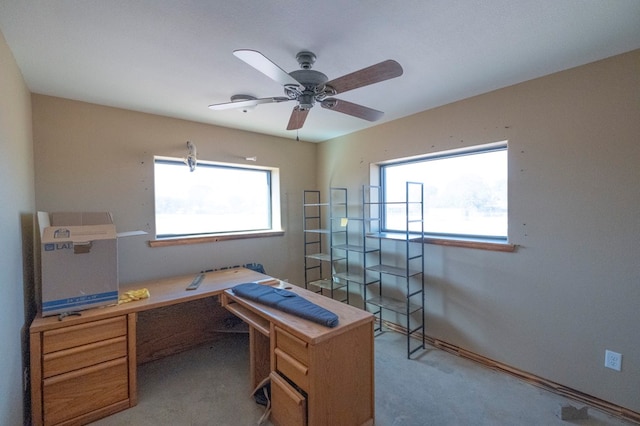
top-left (30, 268), bottom-right (272, 333)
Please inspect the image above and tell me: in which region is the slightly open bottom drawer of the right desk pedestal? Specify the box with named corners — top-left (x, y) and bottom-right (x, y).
top-left (269, 373), bottom-right (307, 426)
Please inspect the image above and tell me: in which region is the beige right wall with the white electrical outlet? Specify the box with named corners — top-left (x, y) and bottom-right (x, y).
top-left (318, 51), bottom-right (640, 412)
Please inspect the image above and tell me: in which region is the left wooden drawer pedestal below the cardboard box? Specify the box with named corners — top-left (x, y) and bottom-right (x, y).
top-left (31, 313), bottom-right (137, 425)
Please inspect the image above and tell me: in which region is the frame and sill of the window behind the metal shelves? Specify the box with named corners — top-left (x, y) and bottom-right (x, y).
top-left (378, 140), bottom-right (516, 252)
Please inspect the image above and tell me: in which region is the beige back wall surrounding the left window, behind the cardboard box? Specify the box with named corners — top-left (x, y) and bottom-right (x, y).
top-left (32, 95), bottom-right (317, 282)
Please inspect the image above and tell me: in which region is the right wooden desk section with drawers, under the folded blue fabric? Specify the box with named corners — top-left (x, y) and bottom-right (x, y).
top-left (222, 286), bottom-right (374, 426)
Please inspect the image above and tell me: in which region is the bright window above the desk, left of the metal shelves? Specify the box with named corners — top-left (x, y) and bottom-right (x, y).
top-left (154, 157), bottom-right (280, 238)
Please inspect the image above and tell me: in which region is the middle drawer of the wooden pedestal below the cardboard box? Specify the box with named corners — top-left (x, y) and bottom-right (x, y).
top-left (42, 336), bottom-right (127, 379)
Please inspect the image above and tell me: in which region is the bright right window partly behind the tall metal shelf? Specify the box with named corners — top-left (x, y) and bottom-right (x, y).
top-left (380, 142), bottom-right (508, 242)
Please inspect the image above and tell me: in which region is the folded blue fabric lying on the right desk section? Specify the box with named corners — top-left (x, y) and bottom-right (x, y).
top-left (232, 283), bottom-right (338, 327)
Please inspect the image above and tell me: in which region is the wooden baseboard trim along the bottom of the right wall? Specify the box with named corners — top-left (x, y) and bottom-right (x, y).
top-left (383, 321), bottom-right (640, 424)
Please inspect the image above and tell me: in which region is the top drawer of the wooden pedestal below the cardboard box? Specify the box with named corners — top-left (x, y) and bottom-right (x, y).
top-left (42, 315), bottom-right (127, 354)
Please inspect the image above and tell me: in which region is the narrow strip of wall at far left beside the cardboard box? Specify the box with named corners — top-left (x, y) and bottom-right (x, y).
top-left (0, 33), bottom-right (34, 425)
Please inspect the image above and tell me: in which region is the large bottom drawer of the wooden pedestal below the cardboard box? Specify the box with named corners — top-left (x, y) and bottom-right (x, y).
top-left (42, 358), bottom-right (129, 425)
